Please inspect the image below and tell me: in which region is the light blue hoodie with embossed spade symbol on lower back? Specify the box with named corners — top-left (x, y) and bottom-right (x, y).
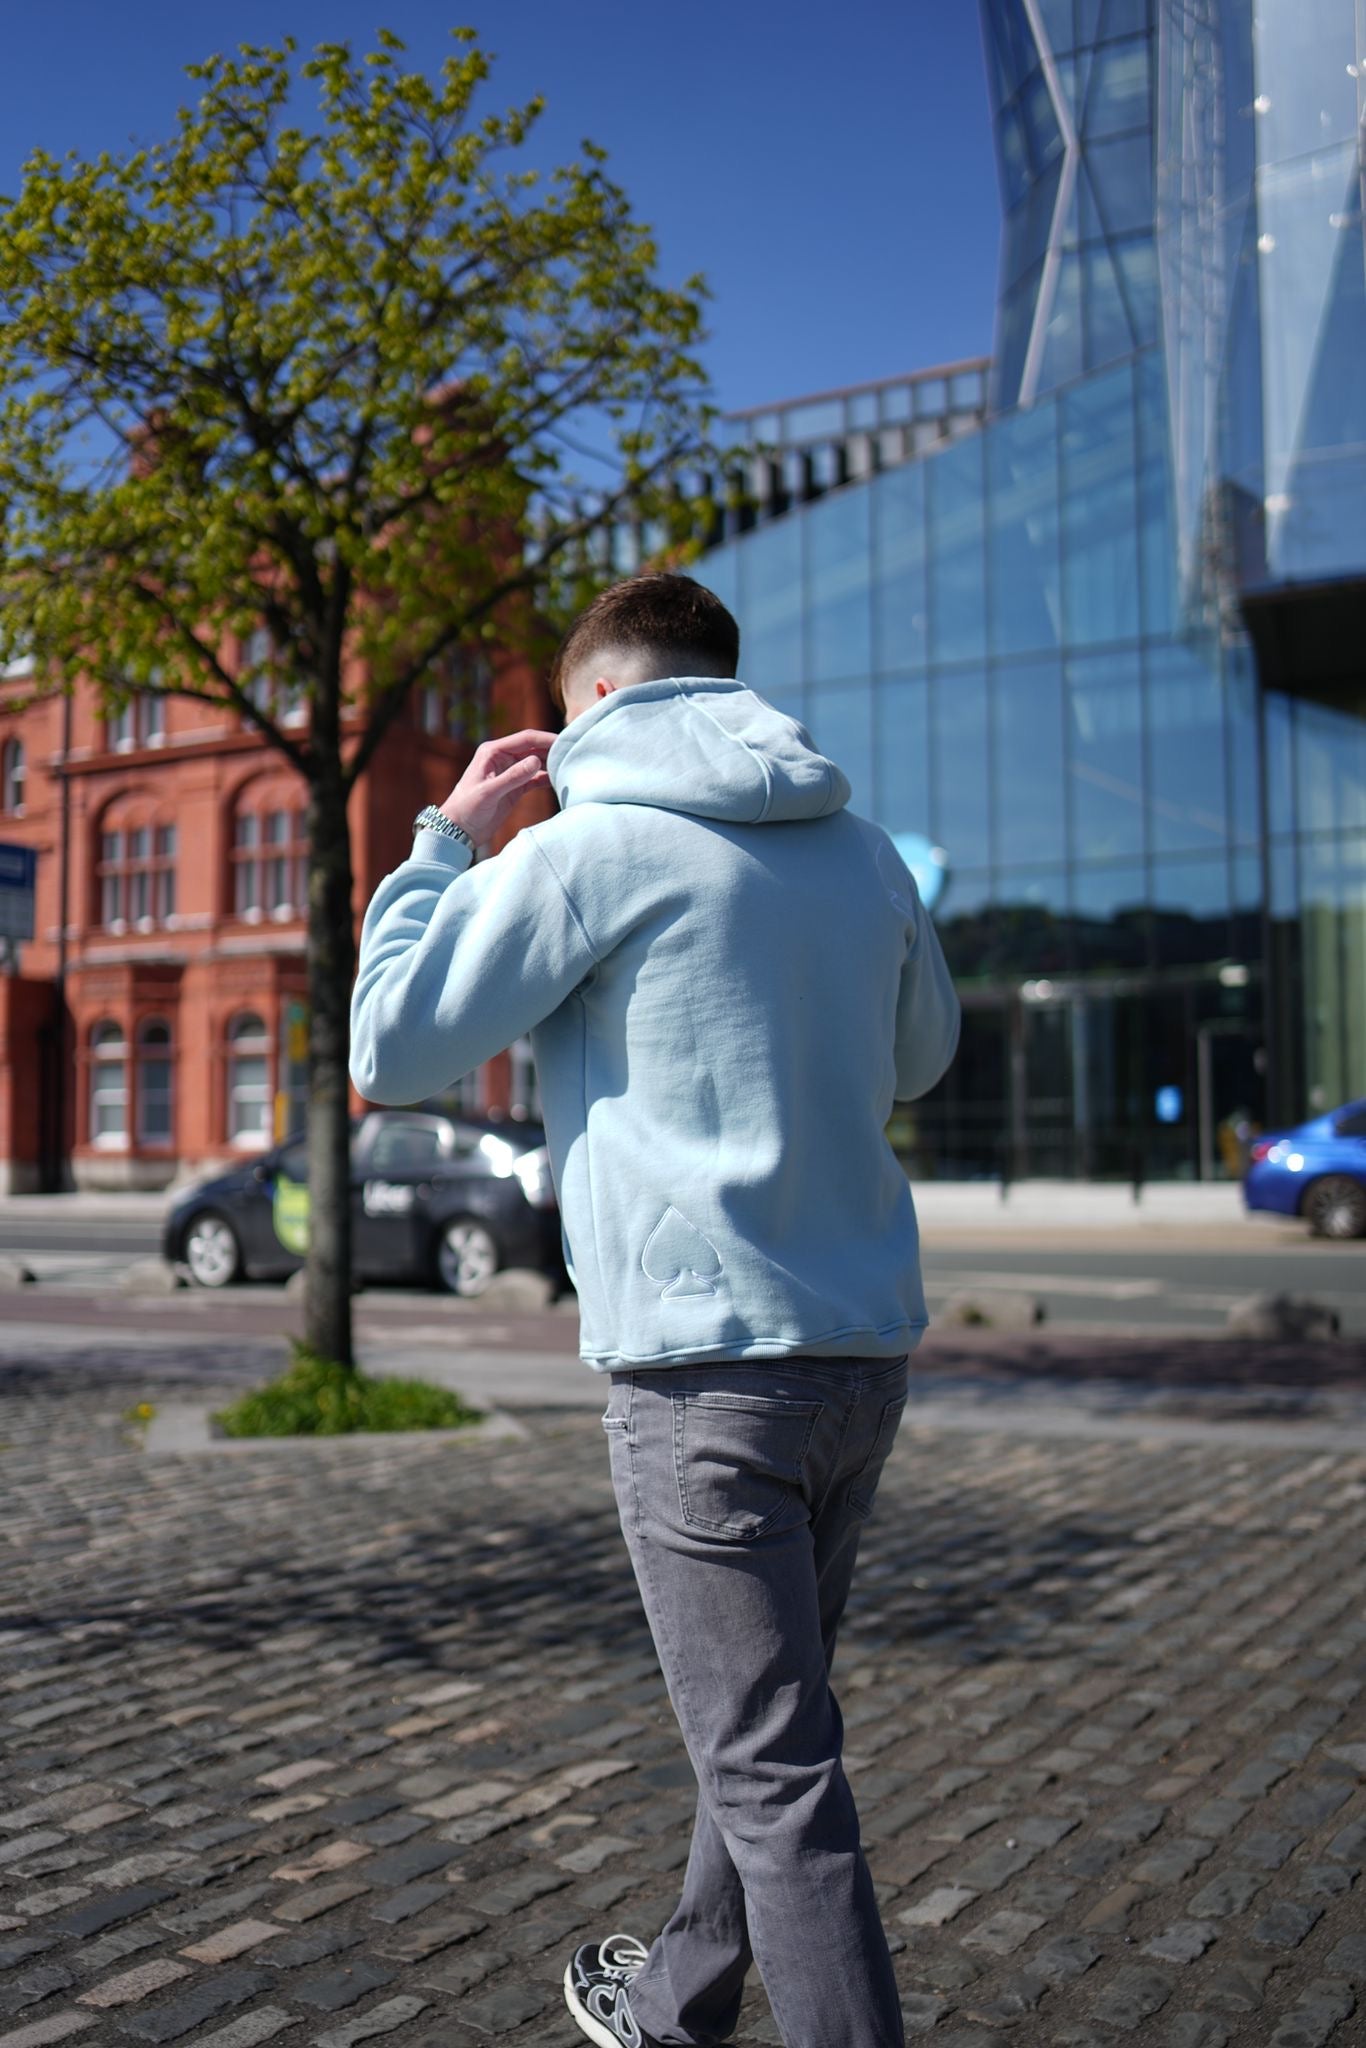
top-left (350, 676), bottom-right (958, 1370)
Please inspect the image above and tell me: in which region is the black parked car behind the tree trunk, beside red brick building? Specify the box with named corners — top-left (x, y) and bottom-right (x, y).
top-left (162, 1110), bottom-right (563, 1294)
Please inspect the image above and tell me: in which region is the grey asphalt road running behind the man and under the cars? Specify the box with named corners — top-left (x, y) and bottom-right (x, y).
top-left (0, 1217), bottom-right (1366, 1335)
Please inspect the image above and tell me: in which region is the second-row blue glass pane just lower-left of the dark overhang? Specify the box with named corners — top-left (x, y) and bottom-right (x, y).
top-left (1147, 647), bottom-right (1229, 854)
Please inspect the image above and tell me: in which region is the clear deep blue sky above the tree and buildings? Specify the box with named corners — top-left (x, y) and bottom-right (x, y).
top-left (0, 0), bottom-right (999, 419)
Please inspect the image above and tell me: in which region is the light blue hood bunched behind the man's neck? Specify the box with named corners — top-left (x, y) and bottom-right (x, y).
top-left (547, 676), bottom-right (850, 825)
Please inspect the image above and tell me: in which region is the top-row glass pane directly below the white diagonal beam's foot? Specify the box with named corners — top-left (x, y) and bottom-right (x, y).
top-left (985, 406), bottom-right (1063, 653)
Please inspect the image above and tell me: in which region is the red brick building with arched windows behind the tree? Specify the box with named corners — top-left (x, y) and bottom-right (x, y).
top-left (0, 643), bottom-right (553, 1192)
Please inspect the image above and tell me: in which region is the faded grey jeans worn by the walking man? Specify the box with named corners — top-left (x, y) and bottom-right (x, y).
top-left (602, 1358), bottom-right (907, 2048)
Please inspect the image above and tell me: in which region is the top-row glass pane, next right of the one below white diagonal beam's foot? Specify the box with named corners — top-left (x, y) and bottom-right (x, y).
top-left (1061, 367), bottom-right (1139, 645)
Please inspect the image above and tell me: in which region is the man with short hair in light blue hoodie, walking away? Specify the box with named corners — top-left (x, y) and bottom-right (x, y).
top-left (352, 575), bottom-right (958, 2048)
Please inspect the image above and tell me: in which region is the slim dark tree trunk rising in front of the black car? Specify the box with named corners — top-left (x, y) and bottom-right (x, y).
top-left (303, 748), bottom-right (356, 1366)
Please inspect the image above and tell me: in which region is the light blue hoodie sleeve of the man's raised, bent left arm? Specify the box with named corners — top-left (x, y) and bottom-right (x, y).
top-left (350, 829), bottom-right (596, 1104)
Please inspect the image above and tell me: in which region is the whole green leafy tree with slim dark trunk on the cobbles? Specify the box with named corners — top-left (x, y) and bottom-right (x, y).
top-left (0, 29), bottom-right (711, 1364)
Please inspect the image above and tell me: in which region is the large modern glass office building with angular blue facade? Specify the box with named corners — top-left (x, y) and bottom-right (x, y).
top-left (696, 0), bottom-right (1366, 1178)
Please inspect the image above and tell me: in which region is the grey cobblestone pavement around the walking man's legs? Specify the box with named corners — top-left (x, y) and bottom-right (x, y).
top-left (0, 1348), bottom-right (1366, 2048)
